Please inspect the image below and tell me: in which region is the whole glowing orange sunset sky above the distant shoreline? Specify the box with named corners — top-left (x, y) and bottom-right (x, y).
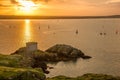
top-left (0, 0), bottom-right (120, 16)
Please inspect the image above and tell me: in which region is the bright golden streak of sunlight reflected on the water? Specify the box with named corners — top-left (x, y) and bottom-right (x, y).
top-left (24, 19), bottom-right (31, 42)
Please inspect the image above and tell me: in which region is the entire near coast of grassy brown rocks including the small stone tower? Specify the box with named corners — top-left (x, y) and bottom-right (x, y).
top-left (0, 42), bottom-right (120, 80)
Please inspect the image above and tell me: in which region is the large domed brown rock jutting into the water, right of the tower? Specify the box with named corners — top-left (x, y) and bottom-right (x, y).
top-left (46, 44), bottom-right (91, 60)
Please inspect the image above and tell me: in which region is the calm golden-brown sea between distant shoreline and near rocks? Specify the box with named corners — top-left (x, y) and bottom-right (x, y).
top-left (0, 19), bottom-right (120, 77)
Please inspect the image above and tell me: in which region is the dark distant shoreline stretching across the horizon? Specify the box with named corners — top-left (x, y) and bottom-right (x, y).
top-left (0, 15), bottom-right (120, 19)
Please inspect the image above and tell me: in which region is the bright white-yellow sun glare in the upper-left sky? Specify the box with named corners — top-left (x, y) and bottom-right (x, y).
top-left (18, 0), bottom-right (37, 13)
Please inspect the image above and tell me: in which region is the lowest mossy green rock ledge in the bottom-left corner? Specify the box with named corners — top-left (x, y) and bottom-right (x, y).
top-left (0, 66), bottom-right (46, 80)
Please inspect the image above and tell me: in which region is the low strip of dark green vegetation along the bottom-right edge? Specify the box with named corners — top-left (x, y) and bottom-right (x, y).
top-left (47, 73), bottom-right (120, 80)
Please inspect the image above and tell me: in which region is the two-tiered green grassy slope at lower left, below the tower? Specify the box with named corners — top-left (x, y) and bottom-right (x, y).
top-left (0, 54), bottom-right (46, 80)
